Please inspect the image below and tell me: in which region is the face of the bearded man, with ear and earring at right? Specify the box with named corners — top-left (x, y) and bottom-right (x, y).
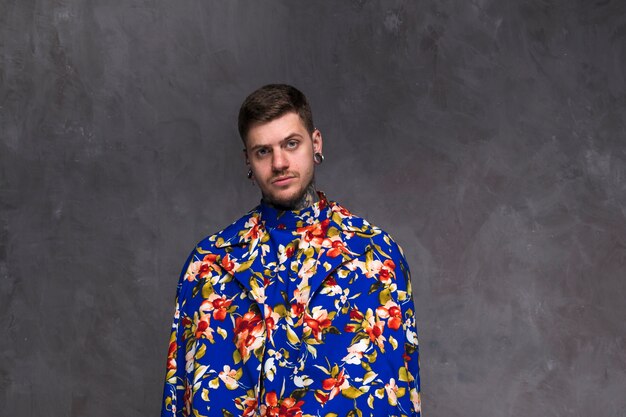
top-left (246, 112), bottom-right (322, 207)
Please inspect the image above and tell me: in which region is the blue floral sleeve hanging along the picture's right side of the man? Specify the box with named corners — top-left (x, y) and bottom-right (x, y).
top-left (392, 242), bottom-right (422, 417)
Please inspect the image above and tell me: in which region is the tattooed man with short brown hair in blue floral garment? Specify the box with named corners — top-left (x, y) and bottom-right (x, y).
top-left (162, 84), bottom-right (420, 417)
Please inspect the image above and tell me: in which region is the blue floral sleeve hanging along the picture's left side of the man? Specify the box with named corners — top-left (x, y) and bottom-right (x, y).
top-left (161, 250), bottom-right (196, 417)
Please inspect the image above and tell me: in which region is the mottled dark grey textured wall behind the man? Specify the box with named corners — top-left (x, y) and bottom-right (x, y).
top-left (0, 0), bottom-right (626, 417)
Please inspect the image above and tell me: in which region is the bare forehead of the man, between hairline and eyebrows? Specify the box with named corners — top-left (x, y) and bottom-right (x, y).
top-left (246, 112), bottom-right (309, 147)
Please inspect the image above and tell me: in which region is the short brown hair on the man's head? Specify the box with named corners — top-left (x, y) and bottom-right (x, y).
top-left (238, 84), bottom-right (315, 143)
